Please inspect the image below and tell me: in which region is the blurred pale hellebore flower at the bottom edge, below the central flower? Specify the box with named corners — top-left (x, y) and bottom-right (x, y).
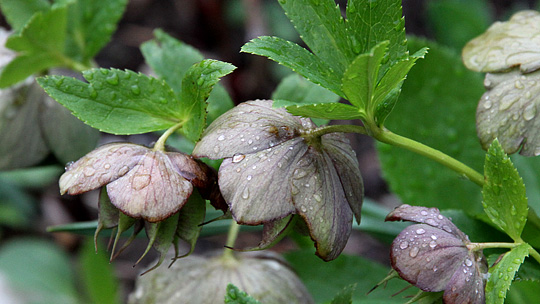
top-left (128, 252), bottom-right (314, 304)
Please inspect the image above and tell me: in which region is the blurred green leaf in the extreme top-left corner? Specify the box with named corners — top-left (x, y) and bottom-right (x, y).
top-left (0, 0), bottom-right (51, 31)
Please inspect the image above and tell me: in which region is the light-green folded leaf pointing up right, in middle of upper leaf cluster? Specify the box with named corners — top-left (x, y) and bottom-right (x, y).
top-left (341, 41), bottom-right (388, 111)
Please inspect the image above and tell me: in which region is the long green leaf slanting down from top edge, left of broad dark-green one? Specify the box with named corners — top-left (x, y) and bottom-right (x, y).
top-left (280, 0), bottom-right (356, 76)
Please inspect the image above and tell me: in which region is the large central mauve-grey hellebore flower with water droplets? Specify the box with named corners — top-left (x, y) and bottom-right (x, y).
top-left (193, 100), bottom-right (363, 260)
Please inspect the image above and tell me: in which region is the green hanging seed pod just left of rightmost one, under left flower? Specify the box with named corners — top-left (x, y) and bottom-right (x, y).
top-left (135, 213), bottom-right (179, 274)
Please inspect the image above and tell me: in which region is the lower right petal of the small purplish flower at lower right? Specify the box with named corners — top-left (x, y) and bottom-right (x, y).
top-left (443, 253), bottom-right (488, 304)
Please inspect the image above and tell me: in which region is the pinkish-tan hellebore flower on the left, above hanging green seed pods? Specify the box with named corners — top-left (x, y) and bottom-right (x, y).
top-left (59, 143), bottom-right (219, 222)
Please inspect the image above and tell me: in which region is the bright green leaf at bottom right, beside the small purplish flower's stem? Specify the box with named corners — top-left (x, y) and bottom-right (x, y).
top-left (486, 243), bottom-right (532, 304)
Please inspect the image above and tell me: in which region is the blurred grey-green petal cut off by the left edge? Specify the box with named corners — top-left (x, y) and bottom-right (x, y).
top-left (0, 84), bottom-right (49, 170)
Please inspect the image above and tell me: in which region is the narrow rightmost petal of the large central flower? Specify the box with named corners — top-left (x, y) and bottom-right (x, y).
top-left (322, 133), bottom-right (364, 224)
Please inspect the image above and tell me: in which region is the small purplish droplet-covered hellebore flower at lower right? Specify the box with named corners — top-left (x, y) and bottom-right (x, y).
top-left (386, 205), bottom-right (488, 304)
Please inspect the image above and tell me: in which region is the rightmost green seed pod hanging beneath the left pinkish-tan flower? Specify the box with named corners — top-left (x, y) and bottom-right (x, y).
top-left (175, 189), bottom-right (206, 260)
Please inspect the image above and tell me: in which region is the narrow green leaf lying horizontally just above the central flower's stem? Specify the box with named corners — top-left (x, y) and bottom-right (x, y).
top-left (286, 103), bottom-right (364, 119)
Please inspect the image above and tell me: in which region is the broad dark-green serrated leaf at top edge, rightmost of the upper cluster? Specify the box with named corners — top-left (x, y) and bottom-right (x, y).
top-left (346, 0), bottom-right (407, 67)
